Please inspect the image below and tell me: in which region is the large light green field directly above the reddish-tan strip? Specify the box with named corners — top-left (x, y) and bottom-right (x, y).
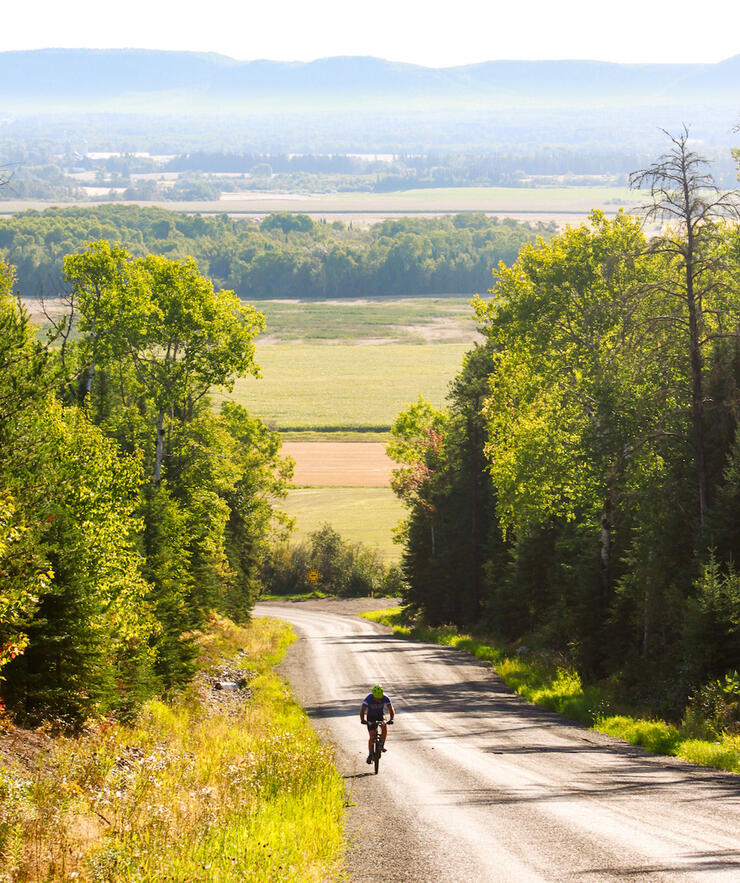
top-left (214, 343), bottom-right (470, 431)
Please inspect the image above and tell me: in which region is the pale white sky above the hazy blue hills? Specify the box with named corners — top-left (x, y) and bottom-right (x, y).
top-left (0, 0), bottom-right (740, 67)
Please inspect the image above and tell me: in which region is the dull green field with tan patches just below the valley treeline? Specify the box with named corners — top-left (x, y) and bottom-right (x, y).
top-left (251, 292), bottom-right (486, 343)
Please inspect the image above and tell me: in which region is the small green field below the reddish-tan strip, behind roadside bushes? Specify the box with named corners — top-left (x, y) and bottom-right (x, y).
top-left (281, 487), bottom-right (404, 561)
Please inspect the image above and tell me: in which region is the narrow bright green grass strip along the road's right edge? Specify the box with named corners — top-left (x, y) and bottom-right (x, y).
top-left (360, 607), bottom-right (740, 773)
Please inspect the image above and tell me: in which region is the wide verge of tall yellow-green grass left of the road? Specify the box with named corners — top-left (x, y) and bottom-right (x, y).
top-left (0, 618), bottom-right (344, 881)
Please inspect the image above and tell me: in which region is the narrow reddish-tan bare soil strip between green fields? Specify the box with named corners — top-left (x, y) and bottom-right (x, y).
top-left (283, 441), bottom-right (394, 487)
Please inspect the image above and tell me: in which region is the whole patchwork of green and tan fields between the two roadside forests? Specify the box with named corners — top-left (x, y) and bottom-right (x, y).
top-left (214, 294), bottom-right (479, 561)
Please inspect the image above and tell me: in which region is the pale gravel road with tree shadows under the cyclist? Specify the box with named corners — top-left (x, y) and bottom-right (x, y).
top-left (256, 601), bottom-right (740, 883)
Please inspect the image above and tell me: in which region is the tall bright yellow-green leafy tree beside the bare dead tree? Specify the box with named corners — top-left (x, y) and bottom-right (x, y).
top-left (476, 212), bottom-right (658, 604)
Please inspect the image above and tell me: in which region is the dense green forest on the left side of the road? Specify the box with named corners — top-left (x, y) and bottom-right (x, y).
top-left (0, 240), bottom-right (291, 723)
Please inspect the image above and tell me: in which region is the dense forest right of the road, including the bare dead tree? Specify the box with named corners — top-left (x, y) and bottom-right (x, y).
top-left (389, 134), bottom-right (740, 719)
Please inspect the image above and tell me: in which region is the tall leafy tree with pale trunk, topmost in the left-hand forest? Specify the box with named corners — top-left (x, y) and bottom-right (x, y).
top-left (65, 242), bottom-right (264, 486)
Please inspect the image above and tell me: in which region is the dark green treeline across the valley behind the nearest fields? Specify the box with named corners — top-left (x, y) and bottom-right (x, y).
top-left (0, 205), bottom-right (552, 299)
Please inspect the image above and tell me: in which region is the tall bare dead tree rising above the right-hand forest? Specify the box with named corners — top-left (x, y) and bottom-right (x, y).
top-left (630, 125), bottom-right (740, 524)
